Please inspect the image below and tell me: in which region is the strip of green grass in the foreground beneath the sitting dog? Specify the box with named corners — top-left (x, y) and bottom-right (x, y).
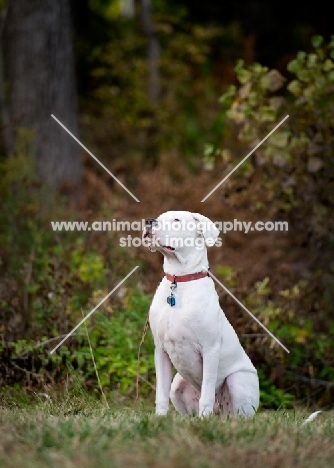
top-left (0, 396), bottom-right (334, 468)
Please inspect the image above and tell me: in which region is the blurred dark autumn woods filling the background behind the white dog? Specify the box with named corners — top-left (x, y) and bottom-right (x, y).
top-left (0, 0), bottom-right (334, 407)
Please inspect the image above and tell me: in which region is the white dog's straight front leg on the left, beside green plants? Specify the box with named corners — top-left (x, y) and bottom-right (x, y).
top-left (154, 346), bottom-right (172, 415)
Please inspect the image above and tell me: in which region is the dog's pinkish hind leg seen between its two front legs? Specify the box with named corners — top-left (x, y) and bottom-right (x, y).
top-left (170, 374), bottom-right (201, 415)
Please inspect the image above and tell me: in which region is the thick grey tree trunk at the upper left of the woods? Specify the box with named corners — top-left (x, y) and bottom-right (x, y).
top-left (3, 0), bottom-right (82, 188)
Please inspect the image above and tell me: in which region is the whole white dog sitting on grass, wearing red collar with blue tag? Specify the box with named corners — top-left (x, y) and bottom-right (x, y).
top-left (143, 211), bottom-right (259, 416)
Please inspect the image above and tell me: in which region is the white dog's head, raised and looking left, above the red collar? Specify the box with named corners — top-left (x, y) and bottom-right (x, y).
top-left (143, 211), bottom-right (219, 270)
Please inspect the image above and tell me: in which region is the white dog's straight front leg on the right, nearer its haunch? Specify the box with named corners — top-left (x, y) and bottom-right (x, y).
top-left (199, 346), bottom-right (220, 416)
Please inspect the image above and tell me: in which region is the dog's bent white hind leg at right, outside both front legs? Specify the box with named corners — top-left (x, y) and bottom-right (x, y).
top-left (219, 371), bottom-right (260, 417)
